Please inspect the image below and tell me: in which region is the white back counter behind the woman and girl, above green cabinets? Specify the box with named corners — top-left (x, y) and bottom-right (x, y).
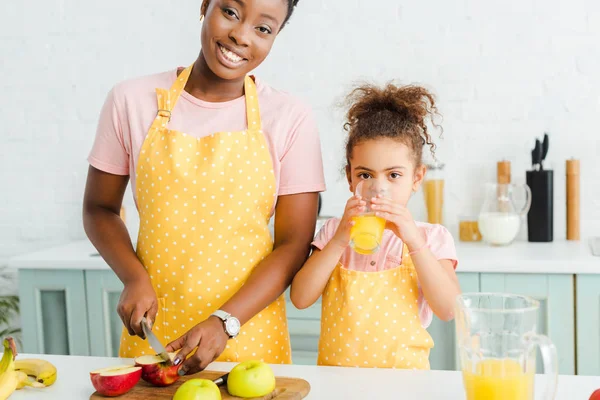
top-left (8, 239), bottom-right (600, 274)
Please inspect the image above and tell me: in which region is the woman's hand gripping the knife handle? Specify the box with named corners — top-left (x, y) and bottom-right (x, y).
top-left (117, 277), bottom-right (158, 338)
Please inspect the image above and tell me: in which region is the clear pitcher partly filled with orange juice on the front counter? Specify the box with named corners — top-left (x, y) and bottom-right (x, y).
top-left (456, 293), bottom-right (558, 400)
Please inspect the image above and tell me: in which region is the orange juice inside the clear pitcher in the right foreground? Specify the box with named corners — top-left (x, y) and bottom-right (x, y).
top-left (463, 359), bottom-right (534, 400)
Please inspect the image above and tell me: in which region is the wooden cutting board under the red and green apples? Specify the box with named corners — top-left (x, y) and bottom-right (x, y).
top-left (90, 371), bottom-right (310, 400)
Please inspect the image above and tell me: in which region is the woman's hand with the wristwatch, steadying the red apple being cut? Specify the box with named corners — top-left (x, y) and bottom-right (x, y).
top-left (166, 317), bottom-right (229, 375)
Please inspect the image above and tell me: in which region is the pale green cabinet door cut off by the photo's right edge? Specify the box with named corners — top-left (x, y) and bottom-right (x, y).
top-left (576, 276), bottom-right (600, 375)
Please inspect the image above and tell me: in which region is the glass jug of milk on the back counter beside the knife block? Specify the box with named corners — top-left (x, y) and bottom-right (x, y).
top-left (478, 183), bottom-right (531, 246)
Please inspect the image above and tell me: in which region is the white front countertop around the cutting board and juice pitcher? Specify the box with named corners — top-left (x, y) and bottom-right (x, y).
top-left (10, 354), bottom-right (600, 400)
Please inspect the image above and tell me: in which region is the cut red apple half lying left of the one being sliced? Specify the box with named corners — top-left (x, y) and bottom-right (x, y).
top-left (90, 365), bottom-right (142, 397)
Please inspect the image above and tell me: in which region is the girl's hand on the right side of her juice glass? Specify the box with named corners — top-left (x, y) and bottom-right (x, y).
top-left (372, 195), bottom-right (426, 250)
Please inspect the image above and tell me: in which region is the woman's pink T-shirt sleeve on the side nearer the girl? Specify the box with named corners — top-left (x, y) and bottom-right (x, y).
top-left (279, 104), bottom-right (325, 195)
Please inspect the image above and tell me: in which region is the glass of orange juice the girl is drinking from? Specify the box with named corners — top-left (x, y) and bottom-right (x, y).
top-left (350, 179), bottom-right (387, 254)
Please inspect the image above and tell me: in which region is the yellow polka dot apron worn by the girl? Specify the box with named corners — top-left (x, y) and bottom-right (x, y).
top-left (318, 246), bottom-right (433, 369)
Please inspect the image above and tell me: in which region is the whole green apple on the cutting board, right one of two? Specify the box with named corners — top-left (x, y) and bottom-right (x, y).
top-left (227, 360), bottom-right (275, 398)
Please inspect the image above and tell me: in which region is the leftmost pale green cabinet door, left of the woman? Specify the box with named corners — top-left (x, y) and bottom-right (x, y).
top-left (19, 270), bottom-right (89, 356)
